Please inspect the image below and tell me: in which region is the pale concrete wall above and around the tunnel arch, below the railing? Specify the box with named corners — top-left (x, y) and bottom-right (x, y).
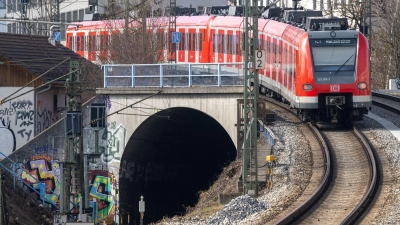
top-left (98, 87), bottom-right (243, 151)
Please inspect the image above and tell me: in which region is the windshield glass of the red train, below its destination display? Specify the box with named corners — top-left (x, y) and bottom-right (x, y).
top-left (311, 46), bottom-right (356, 72)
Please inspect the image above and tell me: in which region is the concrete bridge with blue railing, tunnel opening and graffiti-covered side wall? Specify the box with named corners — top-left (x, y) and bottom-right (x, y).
top-left (3, 64), bottom-right (264, 223)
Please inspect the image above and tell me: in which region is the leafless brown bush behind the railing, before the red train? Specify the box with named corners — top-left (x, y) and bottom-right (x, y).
top-left (98, 0), bottom-right (169, 64)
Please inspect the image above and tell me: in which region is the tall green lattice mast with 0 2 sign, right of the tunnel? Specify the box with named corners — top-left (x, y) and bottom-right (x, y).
top-left (242, 0), bottom-right (258, 197)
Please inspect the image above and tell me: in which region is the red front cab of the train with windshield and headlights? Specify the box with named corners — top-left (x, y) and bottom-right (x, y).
top-left (296, 30), bottom-right (371, 123)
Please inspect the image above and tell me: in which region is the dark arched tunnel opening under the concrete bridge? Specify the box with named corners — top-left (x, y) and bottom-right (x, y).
top-left (119, 107), bottom-right (236, 224)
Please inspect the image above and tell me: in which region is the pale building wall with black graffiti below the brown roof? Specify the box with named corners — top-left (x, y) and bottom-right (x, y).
top-left (0, 87), bottom-right (65, 155)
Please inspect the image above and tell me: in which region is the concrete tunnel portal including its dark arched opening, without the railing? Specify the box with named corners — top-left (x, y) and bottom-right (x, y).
top-left (97, 87), bottom-right (243, 223)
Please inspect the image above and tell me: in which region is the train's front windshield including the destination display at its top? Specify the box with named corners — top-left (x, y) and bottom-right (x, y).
top-left (310, 38), bottom-right (357, 73)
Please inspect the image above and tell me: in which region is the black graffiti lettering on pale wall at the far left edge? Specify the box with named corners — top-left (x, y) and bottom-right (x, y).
top-left (0, 99), bottom-right (35, 155)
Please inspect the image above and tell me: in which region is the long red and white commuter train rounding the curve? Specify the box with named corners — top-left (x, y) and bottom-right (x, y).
top-left (67, 16), bottom-right (371, 122)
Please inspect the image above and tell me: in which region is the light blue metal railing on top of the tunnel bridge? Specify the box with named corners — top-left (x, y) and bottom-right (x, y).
top-left (102, 63), bottom-right (243, 88)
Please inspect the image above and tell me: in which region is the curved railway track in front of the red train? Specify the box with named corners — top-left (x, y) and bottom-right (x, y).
top-left (260, 96), bottom-right (379, 224)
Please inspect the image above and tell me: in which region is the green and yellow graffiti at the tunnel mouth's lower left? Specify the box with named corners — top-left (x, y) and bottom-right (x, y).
top-left (89, 170), bottom-right (117, 221)
